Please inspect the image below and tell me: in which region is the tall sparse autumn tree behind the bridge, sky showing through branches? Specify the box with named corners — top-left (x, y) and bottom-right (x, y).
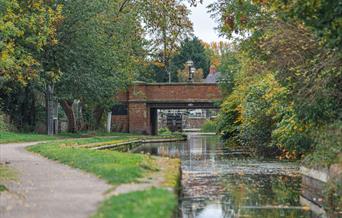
top-left (140, 0), bottom-right (193, 82)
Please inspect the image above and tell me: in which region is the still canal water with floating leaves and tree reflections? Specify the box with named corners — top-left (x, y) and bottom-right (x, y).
top-left (134, 135), bottom-right (319, 218)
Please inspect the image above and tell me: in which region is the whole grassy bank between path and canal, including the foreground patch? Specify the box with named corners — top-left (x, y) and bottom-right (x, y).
top-left (28, 135), bottom-right (179, 218)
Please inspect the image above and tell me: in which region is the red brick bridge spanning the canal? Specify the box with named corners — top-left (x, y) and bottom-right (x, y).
top-left (112, 82), bottom-right (221, 134)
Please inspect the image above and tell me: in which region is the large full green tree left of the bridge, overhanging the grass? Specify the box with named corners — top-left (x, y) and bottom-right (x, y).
top-left (54, 0), bottom-right (144, 131)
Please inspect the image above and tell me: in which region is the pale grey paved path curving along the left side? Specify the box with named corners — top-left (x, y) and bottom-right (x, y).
top-left (0, 143), bottom-right (111, 218)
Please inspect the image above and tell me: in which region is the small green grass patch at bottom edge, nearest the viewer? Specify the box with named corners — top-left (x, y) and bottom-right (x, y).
top-left (92, 189), bottom-right (177, 218)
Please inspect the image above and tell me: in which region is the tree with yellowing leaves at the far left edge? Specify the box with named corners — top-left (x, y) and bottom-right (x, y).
top-left (0, 0), bottom-right (62, 130)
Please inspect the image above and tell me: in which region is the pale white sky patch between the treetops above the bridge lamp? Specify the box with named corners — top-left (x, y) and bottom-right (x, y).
top-left (187, 0), bottom-right (226, 42)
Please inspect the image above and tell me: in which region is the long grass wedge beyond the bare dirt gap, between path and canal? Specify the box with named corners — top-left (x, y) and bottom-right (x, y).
top-left (28, 138), bottom-right (156, 185)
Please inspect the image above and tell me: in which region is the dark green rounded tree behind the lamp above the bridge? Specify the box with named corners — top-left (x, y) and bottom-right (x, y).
top-left (170, 37), bottom-right (210, 80)
